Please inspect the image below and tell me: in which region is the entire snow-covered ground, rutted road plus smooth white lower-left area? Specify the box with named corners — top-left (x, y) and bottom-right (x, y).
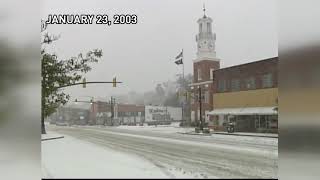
top-left (42, 125), bottom-right (278, 178)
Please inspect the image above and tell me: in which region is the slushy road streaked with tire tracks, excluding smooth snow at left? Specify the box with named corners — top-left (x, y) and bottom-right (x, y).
top-left (48, 126), bottom-right (278, 178)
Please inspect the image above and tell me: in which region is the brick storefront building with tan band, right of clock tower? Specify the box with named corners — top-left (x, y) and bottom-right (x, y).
top-left (208, 57), bottom-right (278, 132)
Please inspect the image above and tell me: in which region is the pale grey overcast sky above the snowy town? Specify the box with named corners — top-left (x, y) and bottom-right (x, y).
top-left (42, 0), bottom-right (278, 101)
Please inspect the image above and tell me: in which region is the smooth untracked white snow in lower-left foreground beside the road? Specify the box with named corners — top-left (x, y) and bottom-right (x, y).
top-left (41, 132), bottom-right (168, 178)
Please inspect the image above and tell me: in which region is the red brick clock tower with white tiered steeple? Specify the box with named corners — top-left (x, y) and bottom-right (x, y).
top-left (189, 7), bottom-right (220, 124)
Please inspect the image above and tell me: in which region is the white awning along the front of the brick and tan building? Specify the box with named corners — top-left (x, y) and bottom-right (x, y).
top-left (208, 107), bottom-right (278, 115)
